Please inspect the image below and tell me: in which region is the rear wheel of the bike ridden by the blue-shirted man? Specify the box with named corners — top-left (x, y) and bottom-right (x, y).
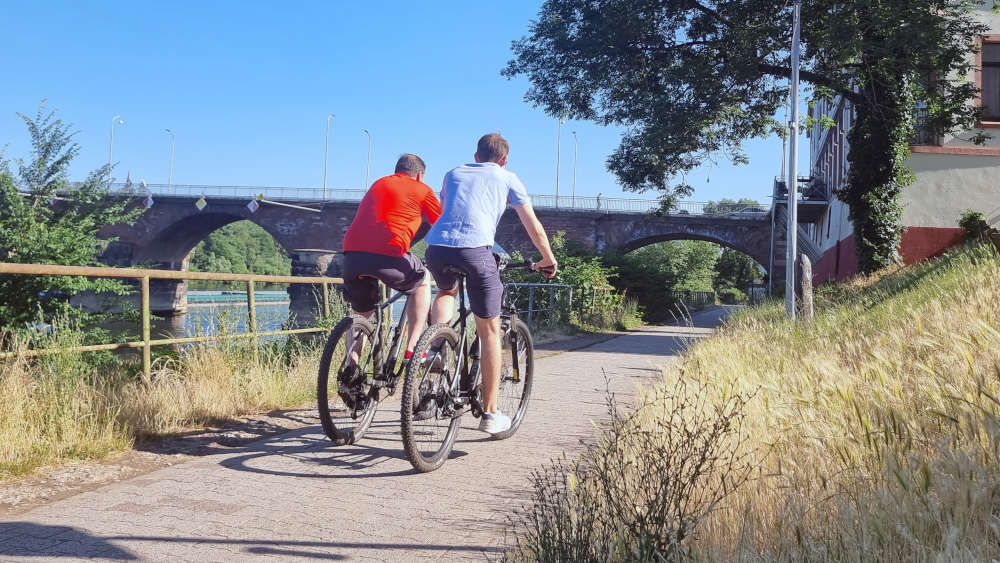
top-left (400, 323), bottom-right (461, 473)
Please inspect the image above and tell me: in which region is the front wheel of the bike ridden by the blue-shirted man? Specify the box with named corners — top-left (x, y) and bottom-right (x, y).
top-left (493, 319), bottom-right (535, 440)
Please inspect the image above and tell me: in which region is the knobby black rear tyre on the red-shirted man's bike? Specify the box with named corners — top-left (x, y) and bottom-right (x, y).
top-left (316, 315), bottom-right (378, 446)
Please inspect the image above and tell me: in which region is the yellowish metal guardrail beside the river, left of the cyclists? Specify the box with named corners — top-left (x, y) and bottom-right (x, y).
top-left (0, 262), bottom-right (343, 377)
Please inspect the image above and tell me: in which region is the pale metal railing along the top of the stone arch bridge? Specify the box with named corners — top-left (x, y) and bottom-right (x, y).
top-left (112, 183), bottom-right (768, 216)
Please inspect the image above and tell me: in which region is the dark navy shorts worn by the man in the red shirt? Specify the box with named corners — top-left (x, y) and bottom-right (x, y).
top-left (343, 252), bottom-right (425, 313)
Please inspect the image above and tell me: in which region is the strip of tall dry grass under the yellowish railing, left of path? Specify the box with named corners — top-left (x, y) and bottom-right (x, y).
top-left (0, 331), bottom-right (319, 479)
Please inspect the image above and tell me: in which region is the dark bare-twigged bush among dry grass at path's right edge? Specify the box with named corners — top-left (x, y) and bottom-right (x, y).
top-left (504, 377), bottom-right (753, 562)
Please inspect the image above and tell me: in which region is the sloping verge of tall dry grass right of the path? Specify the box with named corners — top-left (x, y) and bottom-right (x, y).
top-left (507, 246), bottom-right (1000, 562)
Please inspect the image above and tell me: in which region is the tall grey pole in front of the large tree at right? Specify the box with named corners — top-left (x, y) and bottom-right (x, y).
top-left (785, 0), bottom-right (802, 321)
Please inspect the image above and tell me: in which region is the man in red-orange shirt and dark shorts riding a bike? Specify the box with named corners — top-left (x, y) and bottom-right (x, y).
top-left (343, 154), bottom-right (441, 368)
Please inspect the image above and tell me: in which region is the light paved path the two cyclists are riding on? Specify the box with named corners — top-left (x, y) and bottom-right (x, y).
top-left (0, 311), bottom-right (717, 561)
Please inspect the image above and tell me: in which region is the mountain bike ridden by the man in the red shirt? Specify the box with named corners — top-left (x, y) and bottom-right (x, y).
top-left (316, 284), bottom-right (406, 446)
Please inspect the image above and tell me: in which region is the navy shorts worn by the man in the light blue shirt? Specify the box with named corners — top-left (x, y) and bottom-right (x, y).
top-left (424, 246), bottom-right (503, 319)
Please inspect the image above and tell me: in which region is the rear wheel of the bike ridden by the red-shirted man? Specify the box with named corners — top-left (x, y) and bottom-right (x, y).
top-left (316, 316), bottom-right (381, 446)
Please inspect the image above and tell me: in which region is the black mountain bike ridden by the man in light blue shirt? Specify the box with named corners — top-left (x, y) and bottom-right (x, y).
top-left (400, 255), bottom-right (535, 472)
